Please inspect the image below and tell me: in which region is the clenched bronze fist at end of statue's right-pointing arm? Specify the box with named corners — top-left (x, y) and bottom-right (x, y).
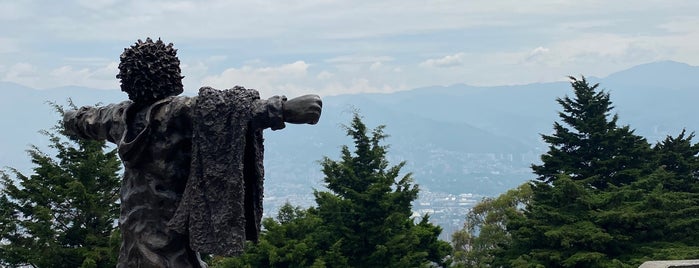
top-left (283, 95), bottom-right (323, 125)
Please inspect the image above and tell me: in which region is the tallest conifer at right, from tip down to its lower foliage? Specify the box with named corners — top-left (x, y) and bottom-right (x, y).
top-left (502, 77), bottom-right (653, 267)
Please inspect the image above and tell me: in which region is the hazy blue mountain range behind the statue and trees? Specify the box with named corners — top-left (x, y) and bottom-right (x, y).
top-left (0, 61), bottom-right (699, 199)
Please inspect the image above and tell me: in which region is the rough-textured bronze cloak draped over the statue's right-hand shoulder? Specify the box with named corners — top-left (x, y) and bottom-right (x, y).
top-left (168, 87), bottom-right (264, 256)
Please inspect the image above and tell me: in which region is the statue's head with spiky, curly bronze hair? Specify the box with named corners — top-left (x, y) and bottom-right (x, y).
top-left (116, 38), bottom-right (184, 104)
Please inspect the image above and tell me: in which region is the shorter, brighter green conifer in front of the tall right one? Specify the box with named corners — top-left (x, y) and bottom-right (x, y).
top-left (502, 175), bottom-right (614, 267)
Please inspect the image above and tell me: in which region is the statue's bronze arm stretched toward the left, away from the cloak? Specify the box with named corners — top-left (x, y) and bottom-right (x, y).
top-left (63, 102), bottom-right (128, 143)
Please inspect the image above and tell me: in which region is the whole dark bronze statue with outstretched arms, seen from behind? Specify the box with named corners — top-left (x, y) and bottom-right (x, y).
top-left (63, 38), bottom-right (322, 267)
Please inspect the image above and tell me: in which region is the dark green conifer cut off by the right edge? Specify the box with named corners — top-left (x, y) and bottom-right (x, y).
top-left (596, 131), bottom-right (699, 265)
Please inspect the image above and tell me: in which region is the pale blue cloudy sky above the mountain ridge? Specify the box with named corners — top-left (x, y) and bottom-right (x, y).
top-left (0, 0), bottom-right (699, 97)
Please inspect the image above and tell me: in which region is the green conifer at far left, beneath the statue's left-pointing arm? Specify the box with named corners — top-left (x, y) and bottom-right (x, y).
top-left (0, 105), bottom-right (120, 267)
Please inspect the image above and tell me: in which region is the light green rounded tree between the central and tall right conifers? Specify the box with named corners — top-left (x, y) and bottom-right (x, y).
top-left (452, 183), bottom-right (532, 267)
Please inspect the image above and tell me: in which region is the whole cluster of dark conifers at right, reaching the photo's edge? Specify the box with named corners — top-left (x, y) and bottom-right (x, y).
top-left (494, 77), bottom-right (699, 267)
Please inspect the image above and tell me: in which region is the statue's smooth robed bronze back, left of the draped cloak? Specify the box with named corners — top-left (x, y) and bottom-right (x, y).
top-left (117, 97), bottom-right (205, 267)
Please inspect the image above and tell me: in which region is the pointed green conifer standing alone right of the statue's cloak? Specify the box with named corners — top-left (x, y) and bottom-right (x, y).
top-left (315, 114), bottom-right (450, 267)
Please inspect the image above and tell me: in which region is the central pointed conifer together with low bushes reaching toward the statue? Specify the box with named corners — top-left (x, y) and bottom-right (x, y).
top-left (213, 114), bottom-right (451, 267)
